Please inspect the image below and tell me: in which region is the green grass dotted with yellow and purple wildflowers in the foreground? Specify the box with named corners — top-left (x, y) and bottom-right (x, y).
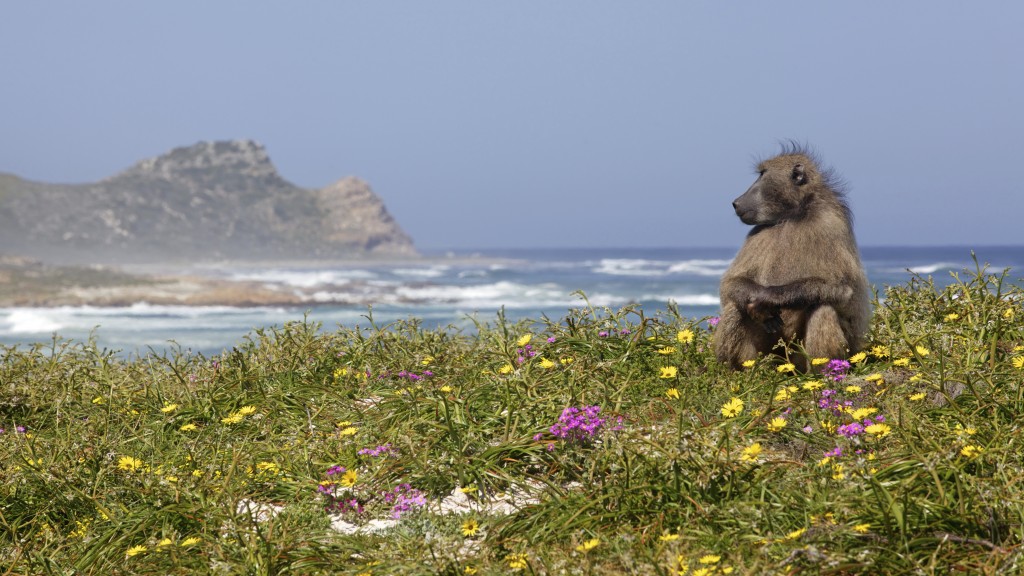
top-left (0, 262), bottom-right (1024, 575)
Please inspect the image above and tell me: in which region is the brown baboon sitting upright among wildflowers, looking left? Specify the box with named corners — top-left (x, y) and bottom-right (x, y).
top-left (714, 143), bottom-right (870, 371)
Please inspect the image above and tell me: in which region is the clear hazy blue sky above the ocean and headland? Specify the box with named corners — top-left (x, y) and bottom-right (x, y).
top-left (0, 0), bottom-right (1024, 250)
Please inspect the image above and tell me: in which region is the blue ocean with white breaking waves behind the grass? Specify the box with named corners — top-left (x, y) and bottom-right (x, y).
top-left (0, 246), bottom-right (1024, 357)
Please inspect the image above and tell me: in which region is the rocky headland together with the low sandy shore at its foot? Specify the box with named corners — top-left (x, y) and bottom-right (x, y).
top-left (0, 140), bottom-right (419, 306)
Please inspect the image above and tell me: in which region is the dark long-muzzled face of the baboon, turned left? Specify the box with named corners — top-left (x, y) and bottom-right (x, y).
top-left (732, 154), bottom-right (814, 225)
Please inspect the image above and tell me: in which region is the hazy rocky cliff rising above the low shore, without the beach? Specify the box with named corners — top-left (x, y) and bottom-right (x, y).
top-left (0, 140), bottom-right (416, 263)
